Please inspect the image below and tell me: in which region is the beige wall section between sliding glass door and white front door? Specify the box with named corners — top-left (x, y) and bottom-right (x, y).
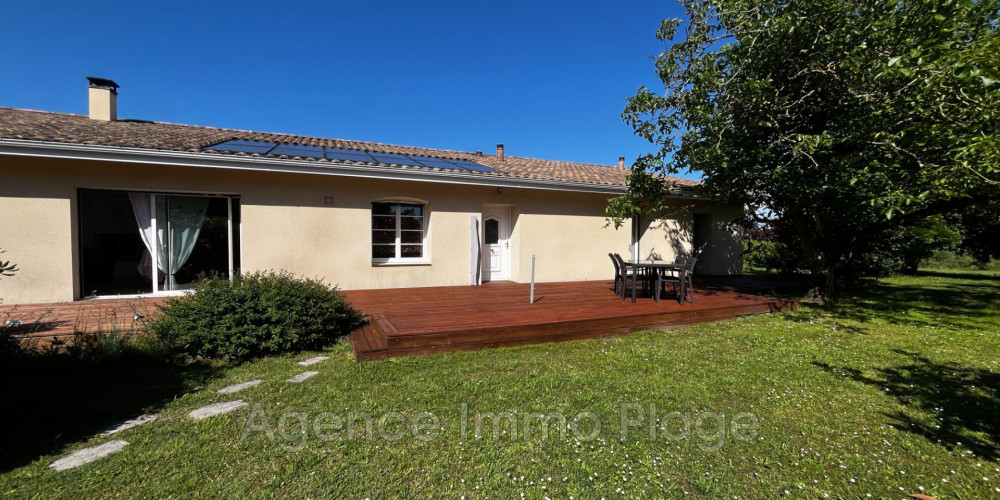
top-left (239, 173), bottom-right (488, 289)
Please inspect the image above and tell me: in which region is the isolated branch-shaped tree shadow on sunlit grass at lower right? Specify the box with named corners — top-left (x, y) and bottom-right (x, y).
top-left (813, 349), bottom-right (1000, 460)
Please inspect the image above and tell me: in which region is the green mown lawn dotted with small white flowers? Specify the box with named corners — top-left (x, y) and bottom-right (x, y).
top-left (0, 272), bottom-right (1000, 499)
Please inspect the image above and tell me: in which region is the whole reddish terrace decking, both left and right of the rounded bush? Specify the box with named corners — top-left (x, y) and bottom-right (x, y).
top-left (0, 277), bottom-right (798, 360)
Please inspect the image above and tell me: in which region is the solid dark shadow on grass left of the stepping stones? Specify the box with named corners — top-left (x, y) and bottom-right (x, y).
top-left (0, 352), bottom-right (220, 473)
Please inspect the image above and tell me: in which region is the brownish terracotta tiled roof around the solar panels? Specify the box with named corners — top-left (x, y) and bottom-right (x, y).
top-left (0, 107), bottom-right (697, 186)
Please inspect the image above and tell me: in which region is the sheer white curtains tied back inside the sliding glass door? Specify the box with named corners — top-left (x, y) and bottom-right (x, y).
top-left (128, 192), bottom-right (208, 290)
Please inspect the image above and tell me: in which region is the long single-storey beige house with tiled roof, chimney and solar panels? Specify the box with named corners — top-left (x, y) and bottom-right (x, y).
top-left (0, 78), bottom-right (741, 304)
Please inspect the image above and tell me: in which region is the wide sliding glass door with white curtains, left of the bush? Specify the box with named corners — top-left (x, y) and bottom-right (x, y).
top-left (79, 189), bottom-right (239, 296)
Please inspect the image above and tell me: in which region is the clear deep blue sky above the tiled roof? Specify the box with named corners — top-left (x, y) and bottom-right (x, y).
top-left (0, 0), bottom-right (681, 180)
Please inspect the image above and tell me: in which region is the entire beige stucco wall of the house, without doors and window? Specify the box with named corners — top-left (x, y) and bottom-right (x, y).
top-left (0, 156), bottom-right (742, 304)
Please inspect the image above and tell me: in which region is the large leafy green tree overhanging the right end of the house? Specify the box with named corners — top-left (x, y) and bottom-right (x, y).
top-left (608, 0), bottom-right (1000, 285)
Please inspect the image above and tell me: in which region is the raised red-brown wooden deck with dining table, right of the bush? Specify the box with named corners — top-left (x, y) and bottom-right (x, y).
top-left (345, 280), bottom-right (798, 360)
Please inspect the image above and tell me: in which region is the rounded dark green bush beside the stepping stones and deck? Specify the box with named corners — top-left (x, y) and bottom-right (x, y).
top-left (152, 272), bottom-right (361, 359)
